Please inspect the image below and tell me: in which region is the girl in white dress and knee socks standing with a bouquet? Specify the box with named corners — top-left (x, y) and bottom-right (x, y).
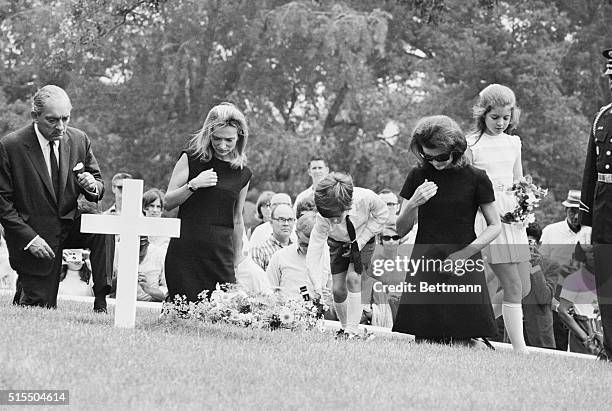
top-left (467, 84), bottom-right (531, 352)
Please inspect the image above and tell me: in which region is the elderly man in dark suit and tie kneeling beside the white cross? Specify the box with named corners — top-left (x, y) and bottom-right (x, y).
top-left (0, 85), bottom-right (114, 312)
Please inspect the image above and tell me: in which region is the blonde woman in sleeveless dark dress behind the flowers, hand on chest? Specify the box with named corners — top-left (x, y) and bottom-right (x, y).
top-left (165, 103), bottom-right (251, 301)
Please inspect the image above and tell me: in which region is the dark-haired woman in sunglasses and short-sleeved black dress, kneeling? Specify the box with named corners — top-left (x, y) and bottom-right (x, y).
top-left (393, 116), bottom-right (501, 344)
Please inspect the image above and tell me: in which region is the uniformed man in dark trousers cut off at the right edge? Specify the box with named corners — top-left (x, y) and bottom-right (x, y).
top-left (580, 49), bottom-right (612, 361)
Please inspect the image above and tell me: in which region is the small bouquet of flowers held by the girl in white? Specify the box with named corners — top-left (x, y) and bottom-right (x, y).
top-left (501, 175), bottom-right (548, 226)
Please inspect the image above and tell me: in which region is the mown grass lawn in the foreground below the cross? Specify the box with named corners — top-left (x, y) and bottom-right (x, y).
top-left (0, 295), bottom-right (612, 410)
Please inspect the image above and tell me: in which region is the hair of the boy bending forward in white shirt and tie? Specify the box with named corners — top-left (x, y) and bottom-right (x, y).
top-left (315, 172), bottom-right (353, 218)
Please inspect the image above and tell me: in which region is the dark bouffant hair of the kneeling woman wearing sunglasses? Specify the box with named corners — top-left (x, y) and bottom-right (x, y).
top-left (410, 115), bottom-right (467, 167)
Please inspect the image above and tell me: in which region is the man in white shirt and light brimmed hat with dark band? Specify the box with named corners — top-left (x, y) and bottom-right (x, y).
top-left (539, 190), bottom-right (591, 351)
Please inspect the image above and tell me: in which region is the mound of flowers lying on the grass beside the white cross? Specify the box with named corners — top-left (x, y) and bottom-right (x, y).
top-left (162, 284), bottom-right (329, 330)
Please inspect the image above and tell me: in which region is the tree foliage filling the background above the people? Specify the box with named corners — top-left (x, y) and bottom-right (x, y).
top-left (0, 0), bottom-right (612, 222)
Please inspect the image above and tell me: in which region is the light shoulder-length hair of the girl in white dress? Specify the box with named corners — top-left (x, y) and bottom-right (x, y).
top-left (472, 84), bottom-right (521, 135)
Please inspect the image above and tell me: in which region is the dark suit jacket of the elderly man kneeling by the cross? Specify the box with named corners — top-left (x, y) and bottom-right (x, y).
top-left (0, 124), bottom-right (104, 276)
